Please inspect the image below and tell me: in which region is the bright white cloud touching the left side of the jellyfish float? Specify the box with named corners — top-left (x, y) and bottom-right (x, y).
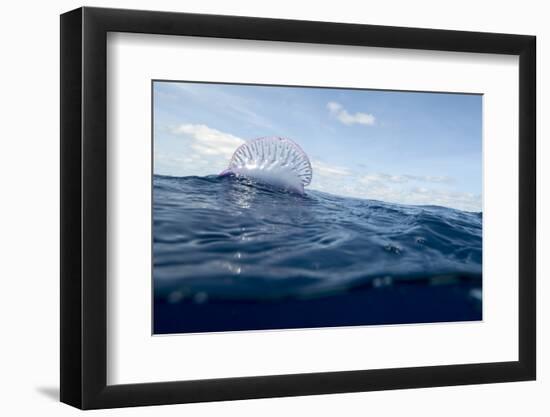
top-left (171, 124), bottom-right (245, 161)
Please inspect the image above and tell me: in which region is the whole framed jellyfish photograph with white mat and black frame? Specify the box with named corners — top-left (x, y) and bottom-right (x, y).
top-left (61, 7), bottom-right (536, 409)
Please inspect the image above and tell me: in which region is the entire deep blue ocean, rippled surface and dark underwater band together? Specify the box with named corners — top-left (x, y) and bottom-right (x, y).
top-left (153, 176), bottom-right (482, 334)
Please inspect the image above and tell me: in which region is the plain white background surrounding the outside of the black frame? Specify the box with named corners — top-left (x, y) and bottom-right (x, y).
top-left (0, 0), bottom-right (550, 417)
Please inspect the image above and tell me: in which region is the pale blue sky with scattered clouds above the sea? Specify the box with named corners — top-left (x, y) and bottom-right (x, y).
top-left (153, 81), bottom-right (482, 211)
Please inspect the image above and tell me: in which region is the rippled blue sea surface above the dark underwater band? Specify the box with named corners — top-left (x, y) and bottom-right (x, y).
top-left (153, 176), bottom-right (482, 304)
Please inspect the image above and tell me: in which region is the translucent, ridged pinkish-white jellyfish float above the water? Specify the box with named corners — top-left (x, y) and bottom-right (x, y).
top-left (220, 137), bottom-right (313, 194)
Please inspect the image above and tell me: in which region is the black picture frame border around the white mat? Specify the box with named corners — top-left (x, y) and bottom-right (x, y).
top-left (60, 7), bottom-right (536, 409)
